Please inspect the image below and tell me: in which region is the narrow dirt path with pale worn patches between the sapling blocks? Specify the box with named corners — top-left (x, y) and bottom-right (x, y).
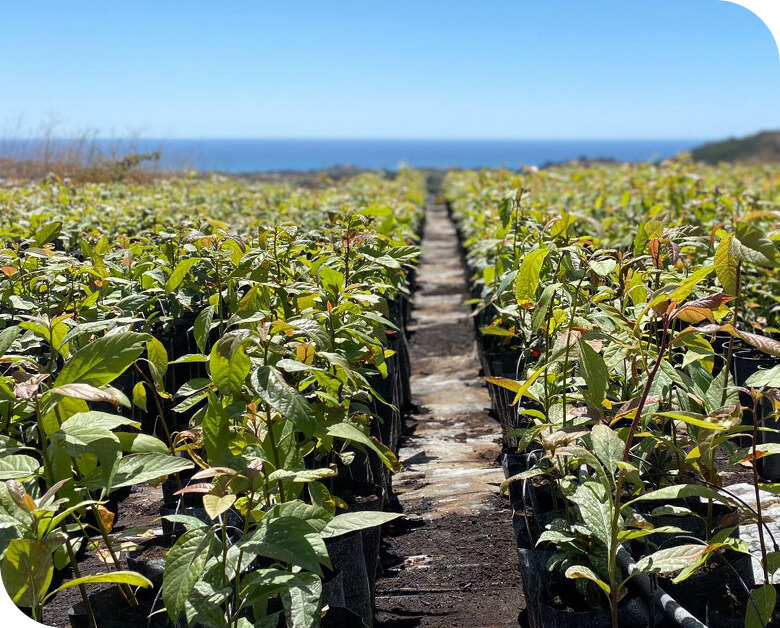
top-left (376, 199), bottom-right (524, 628)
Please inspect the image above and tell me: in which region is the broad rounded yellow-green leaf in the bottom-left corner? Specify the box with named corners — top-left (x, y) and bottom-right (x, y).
top-left (0, 539), bottom-right (54, 608)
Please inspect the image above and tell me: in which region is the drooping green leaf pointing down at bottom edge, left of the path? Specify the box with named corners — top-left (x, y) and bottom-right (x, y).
top-left (162, 528), bottom-right (213, 623)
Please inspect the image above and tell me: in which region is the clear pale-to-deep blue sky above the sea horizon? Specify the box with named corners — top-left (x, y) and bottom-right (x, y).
top-left (0, 0), bottom-right (780, 139)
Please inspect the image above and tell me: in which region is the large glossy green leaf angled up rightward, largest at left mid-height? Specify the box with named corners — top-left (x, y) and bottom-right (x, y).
top-left (54, 331), bottom-right (149, 387)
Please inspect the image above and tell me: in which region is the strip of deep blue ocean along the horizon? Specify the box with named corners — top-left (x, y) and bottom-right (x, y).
top-left (0, 139), bottom-right (704, 174)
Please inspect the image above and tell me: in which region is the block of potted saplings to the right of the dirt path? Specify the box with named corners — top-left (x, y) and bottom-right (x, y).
top-left (444, 159), bottom-right (780, 627)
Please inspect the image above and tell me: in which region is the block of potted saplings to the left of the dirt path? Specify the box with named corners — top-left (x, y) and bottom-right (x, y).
top-left (0, 172), bottom-right (424, 627)
